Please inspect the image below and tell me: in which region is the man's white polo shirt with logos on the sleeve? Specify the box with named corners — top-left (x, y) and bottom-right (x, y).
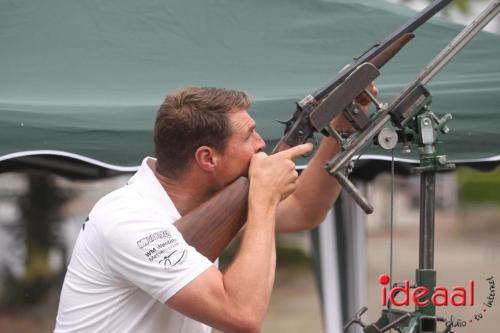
top-left (55, 158), bottom-right (212, 333)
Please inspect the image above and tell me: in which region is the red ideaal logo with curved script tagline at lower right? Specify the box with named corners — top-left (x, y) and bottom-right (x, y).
top-left (378, 274), bottom-right (495, 328)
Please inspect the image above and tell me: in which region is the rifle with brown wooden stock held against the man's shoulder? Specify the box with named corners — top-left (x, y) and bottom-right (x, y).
top-left (174, 0), bottom-right (452, 261)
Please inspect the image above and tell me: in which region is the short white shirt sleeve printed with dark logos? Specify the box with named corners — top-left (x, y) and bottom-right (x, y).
top-left (103, 221), bottom-right (212, 303)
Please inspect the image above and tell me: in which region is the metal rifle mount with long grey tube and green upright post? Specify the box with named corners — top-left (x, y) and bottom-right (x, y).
top-left (325, 0), bottom-right (500, 333)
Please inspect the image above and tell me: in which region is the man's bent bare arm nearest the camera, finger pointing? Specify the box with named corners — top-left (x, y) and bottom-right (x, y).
top-left (167, 144), bottom-right (312, 332)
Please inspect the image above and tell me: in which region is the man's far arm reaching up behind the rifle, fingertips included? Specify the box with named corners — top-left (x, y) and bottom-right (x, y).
top-left (276, 83), bottom-right (378, 232)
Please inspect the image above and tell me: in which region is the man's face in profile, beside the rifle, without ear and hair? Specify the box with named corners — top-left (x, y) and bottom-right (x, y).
top-left (212, 110), bottom-right (266, 186)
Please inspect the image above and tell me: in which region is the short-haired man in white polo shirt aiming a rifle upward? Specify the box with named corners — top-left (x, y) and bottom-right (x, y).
top-left (55, 87), bottom-right (376, 333)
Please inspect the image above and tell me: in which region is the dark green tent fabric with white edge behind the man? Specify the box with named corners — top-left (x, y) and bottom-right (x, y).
top-left (0, 0), bottom-right (500, 170)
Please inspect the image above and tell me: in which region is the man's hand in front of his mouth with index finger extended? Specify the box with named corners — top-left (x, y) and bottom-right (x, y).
top-left (248, 143), bottom-right (313, 204)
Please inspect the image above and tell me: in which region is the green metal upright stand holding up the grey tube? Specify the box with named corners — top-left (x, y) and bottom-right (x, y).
top-left (344, 90), bottom-right (455, 333)
